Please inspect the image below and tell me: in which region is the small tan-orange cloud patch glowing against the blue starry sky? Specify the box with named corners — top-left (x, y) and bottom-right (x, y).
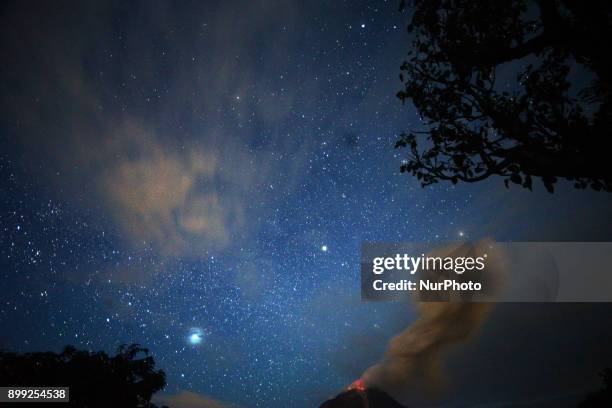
top-left (98, 125), bottom-right (241, 255)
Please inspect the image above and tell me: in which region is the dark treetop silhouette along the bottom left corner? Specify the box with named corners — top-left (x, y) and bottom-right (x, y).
top-left (0, 344), bottom-right (166, 408)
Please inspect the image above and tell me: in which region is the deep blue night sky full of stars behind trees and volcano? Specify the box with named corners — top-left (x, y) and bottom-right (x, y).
top-left (0, 1), bottom-right (612, 407)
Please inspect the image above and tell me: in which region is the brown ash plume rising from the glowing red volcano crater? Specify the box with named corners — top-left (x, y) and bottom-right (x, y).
top-left (361, 240), bottom-right (503, 396)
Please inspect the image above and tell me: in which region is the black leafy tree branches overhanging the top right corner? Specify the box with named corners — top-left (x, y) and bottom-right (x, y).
top-left (396, 0), bottom-right (612, 192)
